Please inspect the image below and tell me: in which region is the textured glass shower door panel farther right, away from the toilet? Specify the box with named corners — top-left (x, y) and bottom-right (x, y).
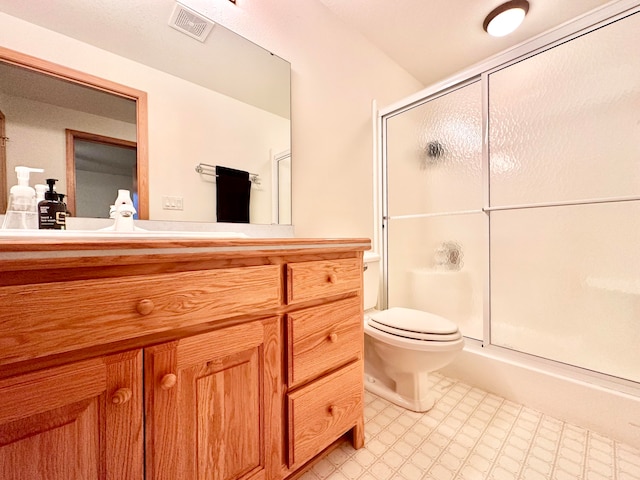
top-left (489, 10), bottom-right (640, 382)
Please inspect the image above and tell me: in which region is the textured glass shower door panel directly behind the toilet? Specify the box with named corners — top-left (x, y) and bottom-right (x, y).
top-left (385, 81), bottom-right (486, 339)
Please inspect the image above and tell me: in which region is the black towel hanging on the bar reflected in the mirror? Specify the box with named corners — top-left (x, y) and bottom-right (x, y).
top-left (216, 166), bottom-right (251, 223)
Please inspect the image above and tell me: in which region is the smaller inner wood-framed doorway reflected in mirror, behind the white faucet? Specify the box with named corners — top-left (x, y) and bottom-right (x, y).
top-left (66, 130), bottom-right (139, 218)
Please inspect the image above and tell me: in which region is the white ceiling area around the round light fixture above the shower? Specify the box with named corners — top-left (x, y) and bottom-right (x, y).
top-left (319, 0), bottom-right (616, 87)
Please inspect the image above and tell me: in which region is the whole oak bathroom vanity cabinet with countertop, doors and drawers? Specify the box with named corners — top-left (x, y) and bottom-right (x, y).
top-left (0, 237), bottom-right (369, 480)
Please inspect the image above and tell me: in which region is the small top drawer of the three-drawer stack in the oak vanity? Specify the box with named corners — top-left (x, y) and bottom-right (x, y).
top-left (287, 258), bottom-right (362, 305)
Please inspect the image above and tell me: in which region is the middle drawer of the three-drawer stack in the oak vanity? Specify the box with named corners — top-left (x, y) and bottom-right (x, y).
top-left (287, 296), bottom-right (364, 386)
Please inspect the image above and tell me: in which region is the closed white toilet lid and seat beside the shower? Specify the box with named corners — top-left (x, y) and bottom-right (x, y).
top-left (369, 307), bottom-right (462, 342)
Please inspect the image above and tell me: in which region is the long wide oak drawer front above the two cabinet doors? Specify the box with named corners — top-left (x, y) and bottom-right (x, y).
top-left (0, 265), bottom-right (282, 364)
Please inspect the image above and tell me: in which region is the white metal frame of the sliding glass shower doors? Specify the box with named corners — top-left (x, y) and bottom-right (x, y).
top-left (373, 0), bottom-right (640, 396)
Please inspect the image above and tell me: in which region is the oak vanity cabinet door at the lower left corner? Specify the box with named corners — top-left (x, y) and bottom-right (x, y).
top-left (0, 350), bottom-right (144, 480)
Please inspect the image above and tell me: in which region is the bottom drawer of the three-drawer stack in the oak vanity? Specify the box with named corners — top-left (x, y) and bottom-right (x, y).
top-left (287, 361), bottom-right (364, 468)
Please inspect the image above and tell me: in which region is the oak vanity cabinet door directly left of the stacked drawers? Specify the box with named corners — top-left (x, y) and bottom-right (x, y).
top-left (145, 318), bottom-right (282, 480)
